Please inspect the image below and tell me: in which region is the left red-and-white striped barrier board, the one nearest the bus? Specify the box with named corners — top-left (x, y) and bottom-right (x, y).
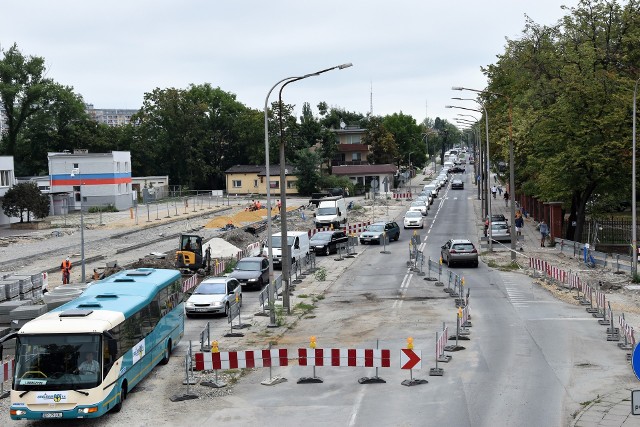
top-left (195, 348), bottom-right (289, 371)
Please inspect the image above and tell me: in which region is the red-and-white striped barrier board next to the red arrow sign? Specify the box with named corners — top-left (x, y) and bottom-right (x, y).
top-left (298, 348), bottom-right (391, 368)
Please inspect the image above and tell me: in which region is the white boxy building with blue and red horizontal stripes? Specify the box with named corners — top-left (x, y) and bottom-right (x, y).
top-left (47, 150), bottom-right (133, 215)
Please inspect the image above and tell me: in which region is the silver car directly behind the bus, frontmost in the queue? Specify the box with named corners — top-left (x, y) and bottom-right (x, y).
top-left (184, 276), bottom-right (242, 317)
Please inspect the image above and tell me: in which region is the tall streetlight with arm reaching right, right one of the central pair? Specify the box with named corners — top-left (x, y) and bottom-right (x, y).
top-left (274, 62), bottom-right (353, 314)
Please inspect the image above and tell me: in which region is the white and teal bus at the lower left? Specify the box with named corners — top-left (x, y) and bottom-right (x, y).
top-left (0, 268), bottom-right (184, 420)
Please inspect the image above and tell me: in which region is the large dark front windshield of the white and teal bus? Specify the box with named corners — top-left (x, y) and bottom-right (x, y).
top-left (14, 334), bottom-right (102, 391)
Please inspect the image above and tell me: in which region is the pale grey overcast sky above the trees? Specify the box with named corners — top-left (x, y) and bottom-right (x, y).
top-left (0, 0), bottom-right (578, 127)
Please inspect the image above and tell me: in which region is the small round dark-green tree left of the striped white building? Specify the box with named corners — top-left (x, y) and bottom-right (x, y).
top-left (2, 182), bottom-right (49, 222)
